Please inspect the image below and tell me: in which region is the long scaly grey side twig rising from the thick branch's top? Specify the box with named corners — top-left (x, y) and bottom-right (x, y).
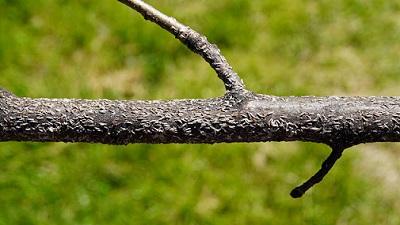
top-left (118, 0), bottom-right (245, 93)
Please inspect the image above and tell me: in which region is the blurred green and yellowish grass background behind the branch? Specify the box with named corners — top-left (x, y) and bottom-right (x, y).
top-left (0, 0), bottom-right (400, 225)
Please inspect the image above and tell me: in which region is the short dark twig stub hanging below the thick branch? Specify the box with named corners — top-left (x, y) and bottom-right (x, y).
top-left (290, 148), bottom-right (344, 198)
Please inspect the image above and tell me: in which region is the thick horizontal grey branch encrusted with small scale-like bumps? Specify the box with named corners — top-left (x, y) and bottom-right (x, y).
top-left (0, 92), bottom-right (400, 148)
